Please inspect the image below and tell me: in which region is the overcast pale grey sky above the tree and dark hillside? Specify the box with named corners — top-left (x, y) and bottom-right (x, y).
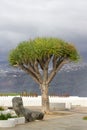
top-left (0, 0), bottom-right (87, 59)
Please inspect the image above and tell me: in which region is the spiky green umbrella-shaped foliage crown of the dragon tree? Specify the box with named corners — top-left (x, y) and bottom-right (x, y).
top-left (9, 38), bottom-right (79, 65)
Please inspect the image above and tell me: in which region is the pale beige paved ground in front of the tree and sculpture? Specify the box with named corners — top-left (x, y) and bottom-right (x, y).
top-left (0, 113), bottom-right (87, 130)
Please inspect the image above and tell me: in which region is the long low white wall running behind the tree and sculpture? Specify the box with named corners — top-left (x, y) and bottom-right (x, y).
top-left (0, 96), bottom-right (87, 109)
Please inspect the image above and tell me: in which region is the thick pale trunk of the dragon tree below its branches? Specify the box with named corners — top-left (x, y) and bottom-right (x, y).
top-left (41, 84), bottom-right (49, 113)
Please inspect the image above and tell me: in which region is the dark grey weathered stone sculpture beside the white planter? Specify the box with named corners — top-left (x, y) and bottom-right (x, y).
top-left (12, 97), bottom-right (44, 122)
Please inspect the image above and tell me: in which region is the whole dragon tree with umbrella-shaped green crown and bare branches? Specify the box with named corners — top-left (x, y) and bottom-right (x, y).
top-left (9, 38), bottom-right (79, 113)
